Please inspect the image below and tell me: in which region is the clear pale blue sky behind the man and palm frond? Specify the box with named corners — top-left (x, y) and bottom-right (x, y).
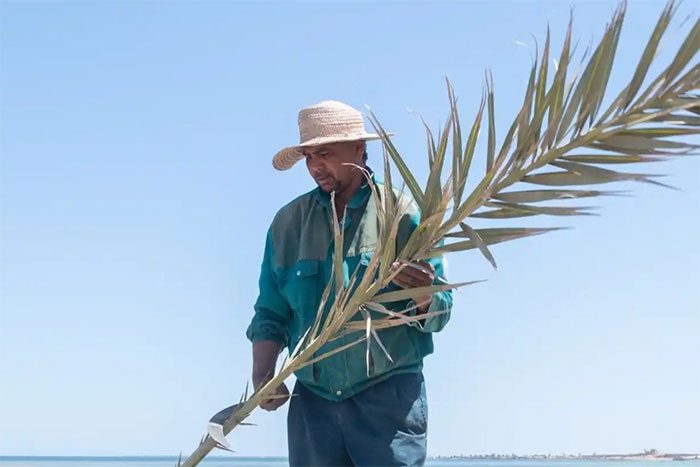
top-left (0, 1), bottom-right (700, 455)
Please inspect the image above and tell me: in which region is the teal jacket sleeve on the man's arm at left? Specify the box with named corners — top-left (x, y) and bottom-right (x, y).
top-left (246, 230), bottom-right (292, 347)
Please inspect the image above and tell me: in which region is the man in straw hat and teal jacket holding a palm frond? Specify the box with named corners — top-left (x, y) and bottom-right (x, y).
top-left (247, 101), bottom-right (452, 466)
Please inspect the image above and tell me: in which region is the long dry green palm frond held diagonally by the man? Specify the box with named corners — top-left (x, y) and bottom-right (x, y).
top-left (178, 1), bottom-right (700, 467)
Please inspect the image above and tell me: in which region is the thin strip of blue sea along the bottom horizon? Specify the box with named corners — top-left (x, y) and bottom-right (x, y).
top-left (0, 456), bottom-right (700, 467)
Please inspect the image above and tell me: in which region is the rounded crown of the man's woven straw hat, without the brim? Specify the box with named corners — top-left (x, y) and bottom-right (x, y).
top-left (298, 100), bottom-right (366, 144)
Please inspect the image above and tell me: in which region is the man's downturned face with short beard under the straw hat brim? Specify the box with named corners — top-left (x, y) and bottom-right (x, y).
top-left (304, 141), bottom-right (365, 193)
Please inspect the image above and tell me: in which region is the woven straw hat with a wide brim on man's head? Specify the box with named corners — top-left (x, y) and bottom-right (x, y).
top-left (272, 101), bottom-right (393, 170)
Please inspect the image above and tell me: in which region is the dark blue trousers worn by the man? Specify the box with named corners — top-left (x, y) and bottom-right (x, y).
top-left (287, 373), bottom-right (428, 467)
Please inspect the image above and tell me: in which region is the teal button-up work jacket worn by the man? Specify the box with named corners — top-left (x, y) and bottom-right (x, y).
top-left (246, 176), bottom-right (452, 400)
